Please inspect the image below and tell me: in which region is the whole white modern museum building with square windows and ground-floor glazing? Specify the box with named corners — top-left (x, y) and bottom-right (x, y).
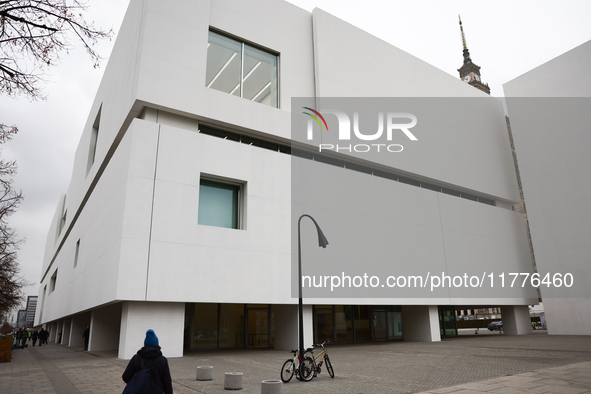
top-left (35, 0), bottom-right (538, 359)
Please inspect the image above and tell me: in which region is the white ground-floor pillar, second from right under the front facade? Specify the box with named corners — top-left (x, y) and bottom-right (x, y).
top-left (402, 305), bottom-right (441, 342)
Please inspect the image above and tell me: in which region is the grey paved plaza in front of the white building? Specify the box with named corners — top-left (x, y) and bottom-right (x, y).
top-left (0, 331), bottom-right (591, 394)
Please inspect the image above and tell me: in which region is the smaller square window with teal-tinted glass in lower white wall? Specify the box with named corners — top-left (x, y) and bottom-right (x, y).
top-left (197, 179), bottom-right (242, 229)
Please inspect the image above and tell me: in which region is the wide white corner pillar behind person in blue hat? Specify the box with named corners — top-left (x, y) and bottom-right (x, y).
top-left (119, 301), bottom-right (185, 360)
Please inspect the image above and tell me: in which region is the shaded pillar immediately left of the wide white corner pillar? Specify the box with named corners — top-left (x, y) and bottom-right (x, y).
top-left (88, 303), bottom-right (121, 352)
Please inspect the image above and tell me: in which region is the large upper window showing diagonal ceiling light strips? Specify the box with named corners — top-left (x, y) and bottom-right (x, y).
top-left (205, 31), bottom-right (278, 107)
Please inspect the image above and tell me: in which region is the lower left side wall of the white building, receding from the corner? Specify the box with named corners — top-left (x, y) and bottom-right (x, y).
top-left (41, 122), bottom-right (137, 323)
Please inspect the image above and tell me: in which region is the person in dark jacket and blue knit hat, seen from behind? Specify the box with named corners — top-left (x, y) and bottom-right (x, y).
top-left (122, 330), bottom-right (172, 394)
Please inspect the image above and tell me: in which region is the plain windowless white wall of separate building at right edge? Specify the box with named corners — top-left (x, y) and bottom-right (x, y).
top-left (504, 41), bottom-right (591, 335)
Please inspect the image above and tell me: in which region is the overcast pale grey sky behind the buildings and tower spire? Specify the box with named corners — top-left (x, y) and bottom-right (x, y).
top-left (0, 0), bottom-right (591, 308)
